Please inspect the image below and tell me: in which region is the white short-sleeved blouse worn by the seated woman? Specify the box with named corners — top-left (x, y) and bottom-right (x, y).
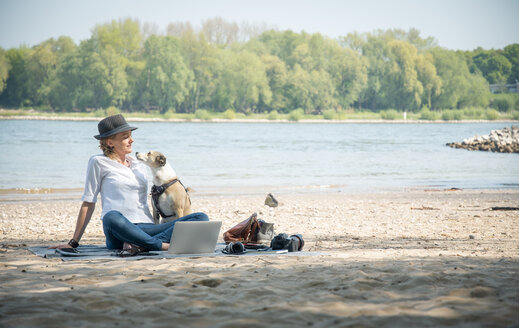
top-left (81, 155), bottom-right (153, 223)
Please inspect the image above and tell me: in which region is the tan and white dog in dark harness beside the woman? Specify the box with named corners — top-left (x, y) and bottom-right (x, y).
top-left (135, 151), bottom-right (193, 224)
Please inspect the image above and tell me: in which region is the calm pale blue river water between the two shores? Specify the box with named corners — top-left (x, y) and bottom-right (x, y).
top-left (0, 120), bottom-right (519, 192)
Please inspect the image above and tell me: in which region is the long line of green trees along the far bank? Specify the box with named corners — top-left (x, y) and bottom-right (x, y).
top-left (0, 18), bottom-right (519, 113)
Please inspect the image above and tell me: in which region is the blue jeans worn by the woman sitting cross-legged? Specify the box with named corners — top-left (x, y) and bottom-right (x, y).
top-left (103, 211), bottom-right (209, 251)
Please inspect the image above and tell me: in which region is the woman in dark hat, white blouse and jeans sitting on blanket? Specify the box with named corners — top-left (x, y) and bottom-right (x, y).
top-left (52, 114), bottom-right (209, 252)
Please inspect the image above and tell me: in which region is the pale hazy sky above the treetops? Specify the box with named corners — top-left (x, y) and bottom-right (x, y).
top-left (0, 0), bottom-right (519, 50)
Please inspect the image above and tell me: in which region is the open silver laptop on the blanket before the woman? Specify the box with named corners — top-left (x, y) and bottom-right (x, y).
top-left (168, 221), bottom-right (222, 254)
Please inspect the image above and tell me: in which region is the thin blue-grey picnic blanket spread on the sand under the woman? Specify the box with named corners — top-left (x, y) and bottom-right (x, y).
top-left (28, 243), bottom-right (323, 261)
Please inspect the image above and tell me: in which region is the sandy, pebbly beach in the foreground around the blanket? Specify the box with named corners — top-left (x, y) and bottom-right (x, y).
top-left (0, 190), bottom-right (519, 328)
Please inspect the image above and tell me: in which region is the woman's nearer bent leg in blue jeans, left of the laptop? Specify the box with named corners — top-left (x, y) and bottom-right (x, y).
top-left (103, 211), bottom-right (162, 251)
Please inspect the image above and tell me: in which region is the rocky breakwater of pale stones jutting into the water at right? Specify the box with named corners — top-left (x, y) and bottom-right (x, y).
top-left (447, 125), bottom-right (519, 153)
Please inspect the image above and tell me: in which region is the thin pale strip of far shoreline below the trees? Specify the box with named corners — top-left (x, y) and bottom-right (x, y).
top-left (0, 115), bottom-right (519, 124)
